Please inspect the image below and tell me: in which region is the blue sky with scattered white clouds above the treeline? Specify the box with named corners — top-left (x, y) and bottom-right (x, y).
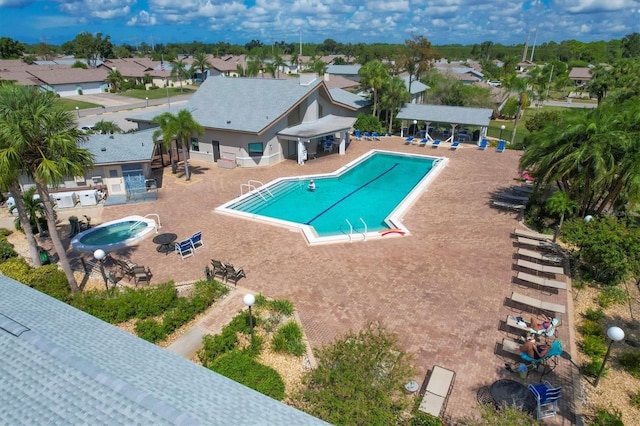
top-left (0, 0), bottom-right (640, 45)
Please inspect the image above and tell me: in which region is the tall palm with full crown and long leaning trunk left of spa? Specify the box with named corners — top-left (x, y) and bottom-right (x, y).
top-left (0, 87), bottom-right (93, 291)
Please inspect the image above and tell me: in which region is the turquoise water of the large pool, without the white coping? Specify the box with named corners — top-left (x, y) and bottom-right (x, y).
top-left (226, 152), bottom-right (438, 237)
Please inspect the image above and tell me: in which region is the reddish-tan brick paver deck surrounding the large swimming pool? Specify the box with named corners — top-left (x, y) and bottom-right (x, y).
top-left (46, 137), bottom-right (580, 424)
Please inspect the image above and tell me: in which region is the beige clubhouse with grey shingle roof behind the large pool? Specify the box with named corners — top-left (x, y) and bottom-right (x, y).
top-left (128, 74), bottom-right (366, 167)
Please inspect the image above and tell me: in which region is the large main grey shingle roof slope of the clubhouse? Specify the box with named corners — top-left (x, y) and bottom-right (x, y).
top-left (131, 76), bottom-right (322, 133)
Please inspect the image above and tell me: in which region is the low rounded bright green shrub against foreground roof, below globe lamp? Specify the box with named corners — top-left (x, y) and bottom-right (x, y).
top-left (211, 350), bottom-right (284, 401)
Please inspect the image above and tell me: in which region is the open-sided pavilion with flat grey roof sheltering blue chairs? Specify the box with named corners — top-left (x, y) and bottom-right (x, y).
top-left (397, 104), bottom-right (493, 142)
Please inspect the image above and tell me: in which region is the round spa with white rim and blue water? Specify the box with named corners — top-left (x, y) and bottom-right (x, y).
top-left (71, 216), bottom-right (156, 253)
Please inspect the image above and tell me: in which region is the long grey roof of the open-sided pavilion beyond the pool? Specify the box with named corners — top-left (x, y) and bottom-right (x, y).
top-left (397, 104), bottom-right (493, 126)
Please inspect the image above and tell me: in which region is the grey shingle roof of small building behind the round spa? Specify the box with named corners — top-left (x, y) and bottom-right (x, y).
top-left (80, 129), bottom-right (156, 165)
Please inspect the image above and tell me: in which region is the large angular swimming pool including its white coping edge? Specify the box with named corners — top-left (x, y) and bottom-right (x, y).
top-left (215, 150), bottom-right (448, 244)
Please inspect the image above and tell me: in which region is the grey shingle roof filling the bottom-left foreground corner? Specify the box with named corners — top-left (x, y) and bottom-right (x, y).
top-left (0, 275), bottom-right (325, 425)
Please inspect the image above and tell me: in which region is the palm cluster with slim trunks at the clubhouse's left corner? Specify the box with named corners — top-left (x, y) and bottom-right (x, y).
top-left (153, 109), bottom-right (204, 180)
